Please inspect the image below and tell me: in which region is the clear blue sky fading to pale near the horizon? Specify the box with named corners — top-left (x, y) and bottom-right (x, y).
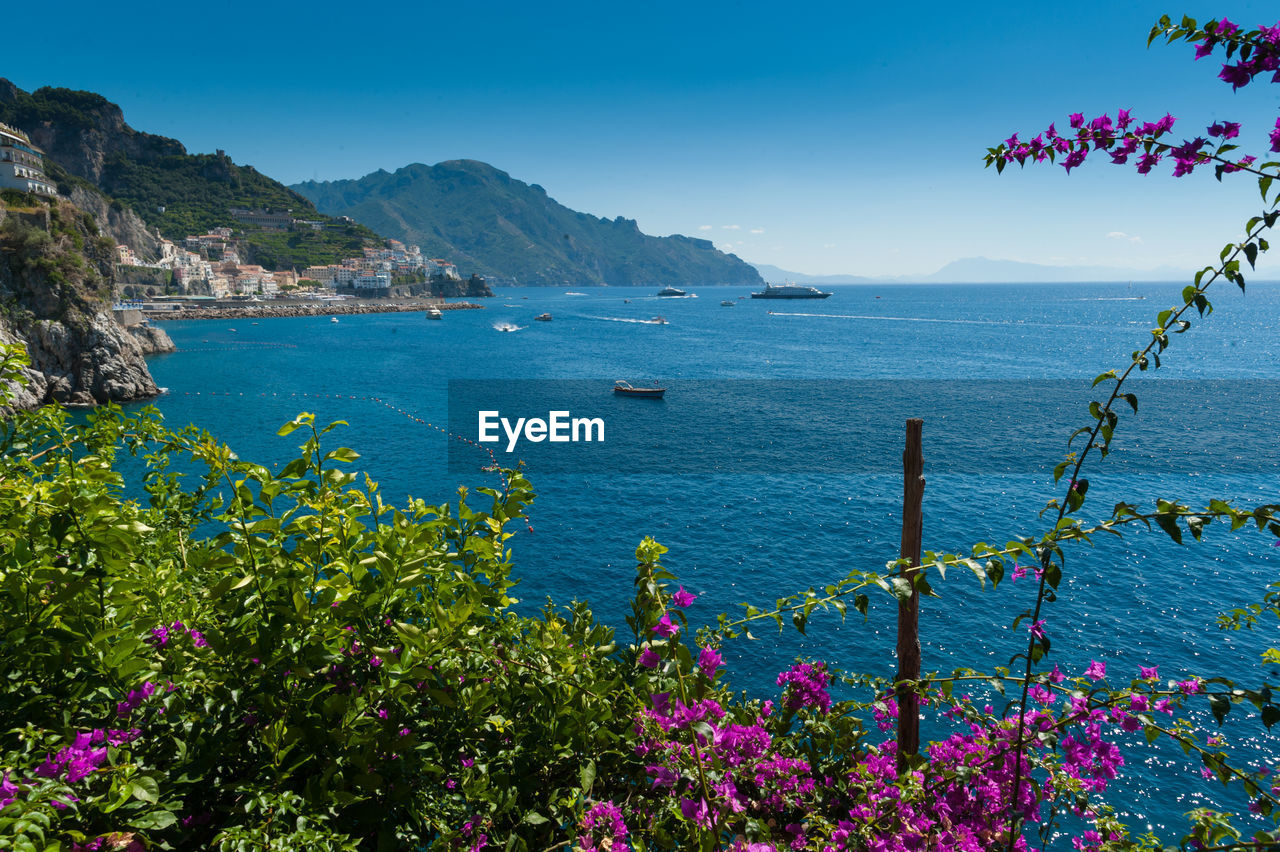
top-left (0, 0), bottom-right (1280, 278)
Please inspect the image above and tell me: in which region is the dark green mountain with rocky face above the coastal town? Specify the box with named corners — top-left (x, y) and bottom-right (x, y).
top-left (0, 78), bottom-right (380, 269)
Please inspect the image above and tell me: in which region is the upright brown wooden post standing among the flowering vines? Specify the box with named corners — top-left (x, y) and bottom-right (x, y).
top-left (893, 418), bottom-right (924, 771)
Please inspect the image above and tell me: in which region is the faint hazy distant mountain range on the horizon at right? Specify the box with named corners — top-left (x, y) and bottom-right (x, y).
top-left (753, 257), bottom-right (1192, 285)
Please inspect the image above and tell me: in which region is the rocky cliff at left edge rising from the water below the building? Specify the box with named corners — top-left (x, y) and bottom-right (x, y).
top-left (0, 193), bottom-right (159, 408)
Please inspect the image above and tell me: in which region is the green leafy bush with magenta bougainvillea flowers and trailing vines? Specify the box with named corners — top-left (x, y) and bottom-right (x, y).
top-left (0, 11), bottom-right (1280, 851)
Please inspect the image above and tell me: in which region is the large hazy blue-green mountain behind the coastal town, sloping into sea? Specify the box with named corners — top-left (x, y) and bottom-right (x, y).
top-left (292, 160), bottom-right (762, 287)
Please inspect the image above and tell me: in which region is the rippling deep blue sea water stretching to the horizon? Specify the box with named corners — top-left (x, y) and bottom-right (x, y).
top-left (132, 284), bottom-right (1280, 838)
